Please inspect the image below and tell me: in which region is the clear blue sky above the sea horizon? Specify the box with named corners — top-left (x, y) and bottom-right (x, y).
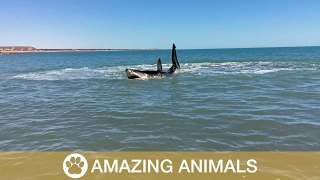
top-left (0, 0), bottom-right (320, 49)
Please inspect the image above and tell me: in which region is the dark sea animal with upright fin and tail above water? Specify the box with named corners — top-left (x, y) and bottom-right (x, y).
top-left (125, 44), bottom-right (180, 79)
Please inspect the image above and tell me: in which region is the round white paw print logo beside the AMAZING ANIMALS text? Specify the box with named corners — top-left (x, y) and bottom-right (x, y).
top-left (63, 153), bottom-right (88, 178)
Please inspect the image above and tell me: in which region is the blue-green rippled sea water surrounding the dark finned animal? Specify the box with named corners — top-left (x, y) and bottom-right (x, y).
top-left (0, 45), bottom-right (320, 151)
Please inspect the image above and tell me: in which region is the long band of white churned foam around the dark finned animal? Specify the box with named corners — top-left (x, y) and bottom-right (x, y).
top-left (12, 62), bottom-right (319, 80)
